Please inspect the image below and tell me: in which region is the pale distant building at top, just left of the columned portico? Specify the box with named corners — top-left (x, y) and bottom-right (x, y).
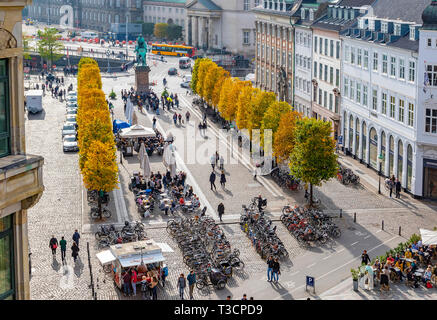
top-left (143, 0), bottom-right (187, 29)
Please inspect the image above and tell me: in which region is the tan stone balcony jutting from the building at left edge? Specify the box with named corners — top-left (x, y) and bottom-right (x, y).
top-left (0, 154), bottom-right (44, 209)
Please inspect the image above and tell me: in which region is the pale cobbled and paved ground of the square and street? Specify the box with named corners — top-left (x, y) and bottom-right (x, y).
top-left (26, 49), bottom-right (437, 300)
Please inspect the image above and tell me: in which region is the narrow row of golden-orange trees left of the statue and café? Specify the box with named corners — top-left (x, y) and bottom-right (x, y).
top-left (77, 58), bottom-right (118, 218)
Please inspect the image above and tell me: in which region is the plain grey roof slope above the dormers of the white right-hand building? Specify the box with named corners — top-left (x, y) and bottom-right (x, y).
top-left (373, 0), bottom-right (431, 24)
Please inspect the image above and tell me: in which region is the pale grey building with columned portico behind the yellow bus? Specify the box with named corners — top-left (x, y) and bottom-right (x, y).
top-left (185, 0), bottom-right (261, 58)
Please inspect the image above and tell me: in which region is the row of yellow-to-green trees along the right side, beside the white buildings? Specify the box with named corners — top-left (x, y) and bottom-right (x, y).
top-left (191, 58), bottom-right (337, 203)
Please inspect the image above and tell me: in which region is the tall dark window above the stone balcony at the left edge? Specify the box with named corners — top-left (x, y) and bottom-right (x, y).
top-left (0, 59), bottom-right (10, 157)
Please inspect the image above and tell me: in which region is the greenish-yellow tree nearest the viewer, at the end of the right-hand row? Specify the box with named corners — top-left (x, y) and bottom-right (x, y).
top-left (290, 118), bottom-right (338, 206)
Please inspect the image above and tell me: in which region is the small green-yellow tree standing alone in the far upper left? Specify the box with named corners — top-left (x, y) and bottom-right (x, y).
top-left (36, 28), bottom-right (64, 69)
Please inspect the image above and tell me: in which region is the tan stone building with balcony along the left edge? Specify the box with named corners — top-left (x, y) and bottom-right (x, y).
top-left (0, 0), bottom-right (44, 300)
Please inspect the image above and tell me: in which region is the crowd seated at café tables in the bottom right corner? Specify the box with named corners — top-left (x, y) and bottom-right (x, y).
top-left (361, 241), bottom-right (437, 291)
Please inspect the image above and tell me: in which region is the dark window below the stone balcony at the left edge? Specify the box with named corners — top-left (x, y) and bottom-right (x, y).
top-left (0, 215), bottom-right (15, 300)
